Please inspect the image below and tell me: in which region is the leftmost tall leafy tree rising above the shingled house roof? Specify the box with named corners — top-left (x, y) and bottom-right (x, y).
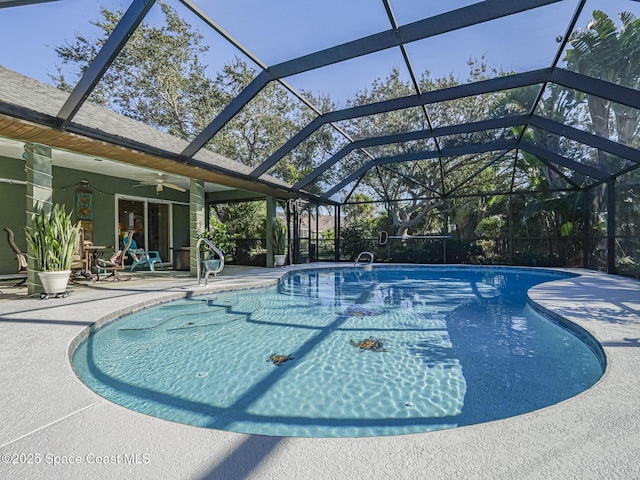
top-left (51, 2), bottom-right (224, 140)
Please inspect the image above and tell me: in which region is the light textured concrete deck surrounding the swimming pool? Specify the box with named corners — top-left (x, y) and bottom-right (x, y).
top-left (0, 264), bottom-right (640, 480)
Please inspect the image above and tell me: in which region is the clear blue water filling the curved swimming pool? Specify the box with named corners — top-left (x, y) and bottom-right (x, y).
top-left (73, 267), bottom-right (604, 437)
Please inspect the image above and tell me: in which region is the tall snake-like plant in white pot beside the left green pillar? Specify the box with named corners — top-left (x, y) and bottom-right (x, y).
top-left (24, 204), bottom-right (80, 295)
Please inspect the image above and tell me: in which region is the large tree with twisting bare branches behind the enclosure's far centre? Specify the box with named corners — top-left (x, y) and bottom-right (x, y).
top-left (348, 59), bottom-right (510, 235)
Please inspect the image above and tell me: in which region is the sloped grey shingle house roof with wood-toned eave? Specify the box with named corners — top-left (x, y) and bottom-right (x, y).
top-left (0, 65), bottom-right (291, 198)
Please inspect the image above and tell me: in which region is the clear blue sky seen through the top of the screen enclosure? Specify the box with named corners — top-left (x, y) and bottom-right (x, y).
top-left (0, 0), bottom-right (640, 107)
